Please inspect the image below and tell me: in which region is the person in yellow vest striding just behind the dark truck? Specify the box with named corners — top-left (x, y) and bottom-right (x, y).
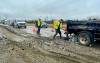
top-left (53, 19), bottom-right (62, 39)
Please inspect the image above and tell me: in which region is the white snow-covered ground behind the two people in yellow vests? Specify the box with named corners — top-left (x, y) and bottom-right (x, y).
top-left (23, 26), bottom-right (65, 37)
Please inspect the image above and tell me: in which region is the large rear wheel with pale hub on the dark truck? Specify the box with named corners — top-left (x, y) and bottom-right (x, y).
top-left (78, 32), bottom-right (93, 46)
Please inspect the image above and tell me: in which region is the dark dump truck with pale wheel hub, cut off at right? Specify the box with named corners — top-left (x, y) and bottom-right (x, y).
top-left (66, 20), bottom-right (100, 46)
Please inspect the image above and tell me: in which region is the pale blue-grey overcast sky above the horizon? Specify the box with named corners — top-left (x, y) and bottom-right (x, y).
top-left (0, 0), bottom-right (100, 19)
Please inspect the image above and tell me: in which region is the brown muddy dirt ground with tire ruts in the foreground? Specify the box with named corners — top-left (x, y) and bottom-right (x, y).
top-left (0, 26), bottom-right (100, 63)
